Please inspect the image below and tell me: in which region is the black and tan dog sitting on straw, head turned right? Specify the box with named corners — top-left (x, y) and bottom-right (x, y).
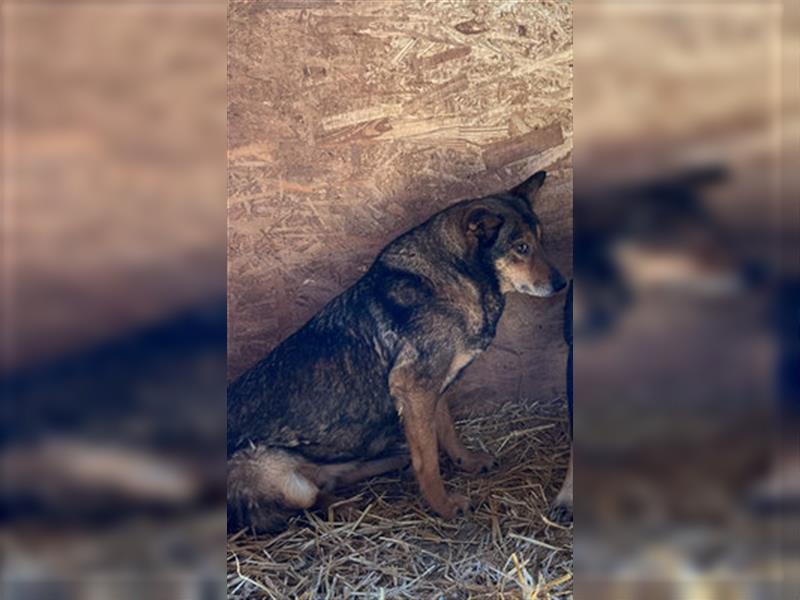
top-left (228, 171), bottom-right (566, 530)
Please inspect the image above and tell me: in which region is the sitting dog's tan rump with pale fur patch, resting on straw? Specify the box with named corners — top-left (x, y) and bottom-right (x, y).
top-left (228, 446), bottom-right (320, 531)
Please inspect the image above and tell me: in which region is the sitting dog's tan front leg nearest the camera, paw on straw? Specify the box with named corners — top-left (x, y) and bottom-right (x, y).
top-left (389, 360), bottom-right (469, 519)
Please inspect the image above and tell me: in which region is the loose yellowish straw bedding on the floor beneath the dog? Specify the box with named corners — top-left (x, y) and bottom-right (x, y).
top-left (227, 398), bottom-right (572, 599)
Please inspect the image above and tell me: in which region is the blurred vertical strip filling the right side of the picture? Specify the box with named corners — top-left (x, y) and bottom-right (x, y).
top-left (573, 1), bottom-right (800, 599)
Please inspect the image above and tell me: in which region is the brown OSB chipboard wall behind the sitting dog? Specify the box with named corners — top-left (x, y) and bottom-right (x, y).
top-left (228, 1), bottom-right (572, 414)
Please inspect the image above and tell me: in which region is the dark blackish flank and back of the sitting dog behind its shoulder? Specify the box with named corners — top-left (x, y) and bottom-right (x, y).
top-left (228, 275), bottom-right (400, 461)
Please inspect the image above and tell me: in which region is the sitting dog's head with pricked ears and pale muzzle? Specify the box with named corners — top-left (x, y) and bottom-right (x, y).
top-left (462, 171), bottom-right (566, 298)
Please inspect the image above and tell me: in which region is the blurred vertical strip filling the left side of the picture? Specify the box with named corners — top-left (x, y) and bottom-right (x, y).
top-left (0, 0), bottom-right (226, 599)
